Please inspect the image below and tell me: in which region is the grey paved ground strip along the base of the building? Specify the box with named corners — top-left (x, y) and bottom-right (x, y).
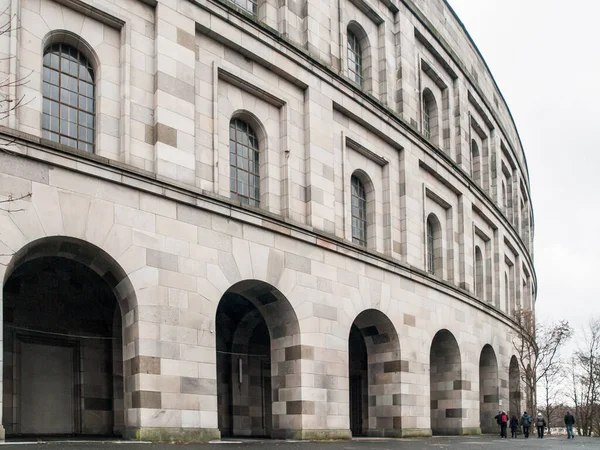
top-left (0, 436), bottom-right (600, 450)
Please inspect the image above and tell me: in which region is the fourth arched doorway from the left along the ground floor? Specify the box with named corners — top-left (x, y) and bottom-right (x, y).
top-left (429, 330), bottom-right (467, 435)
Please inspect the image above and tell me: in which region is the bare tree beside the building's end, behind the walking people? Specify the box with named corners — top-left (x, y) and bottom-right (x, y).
top-left (512, 309), bottom-right (573, 413)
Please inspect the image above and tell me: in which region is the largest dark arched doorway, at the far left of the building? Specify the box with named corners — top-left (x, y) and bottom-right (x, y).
top-left (2, 236), bottom-right (134, 436)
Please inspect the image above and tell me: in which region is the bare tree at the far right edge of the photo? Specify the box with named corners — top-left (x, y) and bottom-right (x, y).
top-left (571, 318), bottom-right (600, 436)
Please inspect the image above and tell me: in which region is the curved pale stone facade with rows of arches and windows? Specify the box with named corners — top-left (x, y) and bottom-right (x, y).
top-left (0, 0), bottom-right (536, 440)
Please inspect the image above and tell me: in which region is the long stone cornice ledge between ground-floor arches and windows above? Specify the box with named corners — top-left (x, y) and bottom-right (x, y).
top-left (0, 125), bottom-right (514, 324)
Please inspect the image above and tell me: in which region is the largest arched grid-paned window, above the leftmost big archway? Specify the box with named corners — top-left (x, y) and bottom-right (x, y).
top-left (42, 44), bottom-right (96, 152)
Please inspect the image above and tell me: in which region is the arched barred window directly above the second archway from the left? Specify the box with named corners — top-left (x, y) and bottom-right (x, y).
top-left (229, 119), bottom-right (260, 206)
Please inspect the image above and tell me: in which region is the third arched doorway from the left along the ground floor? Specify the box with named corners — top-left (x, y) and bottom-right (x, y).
top-left (348, 309), bottom-right (400, 436)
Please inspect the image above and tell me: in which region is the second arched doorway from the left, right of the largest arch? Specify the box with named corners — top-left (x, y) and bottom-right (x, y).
top-left (216, 280), bottom-right (303, 437)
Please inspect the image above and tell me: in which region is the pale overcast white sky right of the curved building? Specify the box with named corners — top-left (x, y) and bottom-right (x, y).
top-left (449, 0), bottom-right (600, 338)
